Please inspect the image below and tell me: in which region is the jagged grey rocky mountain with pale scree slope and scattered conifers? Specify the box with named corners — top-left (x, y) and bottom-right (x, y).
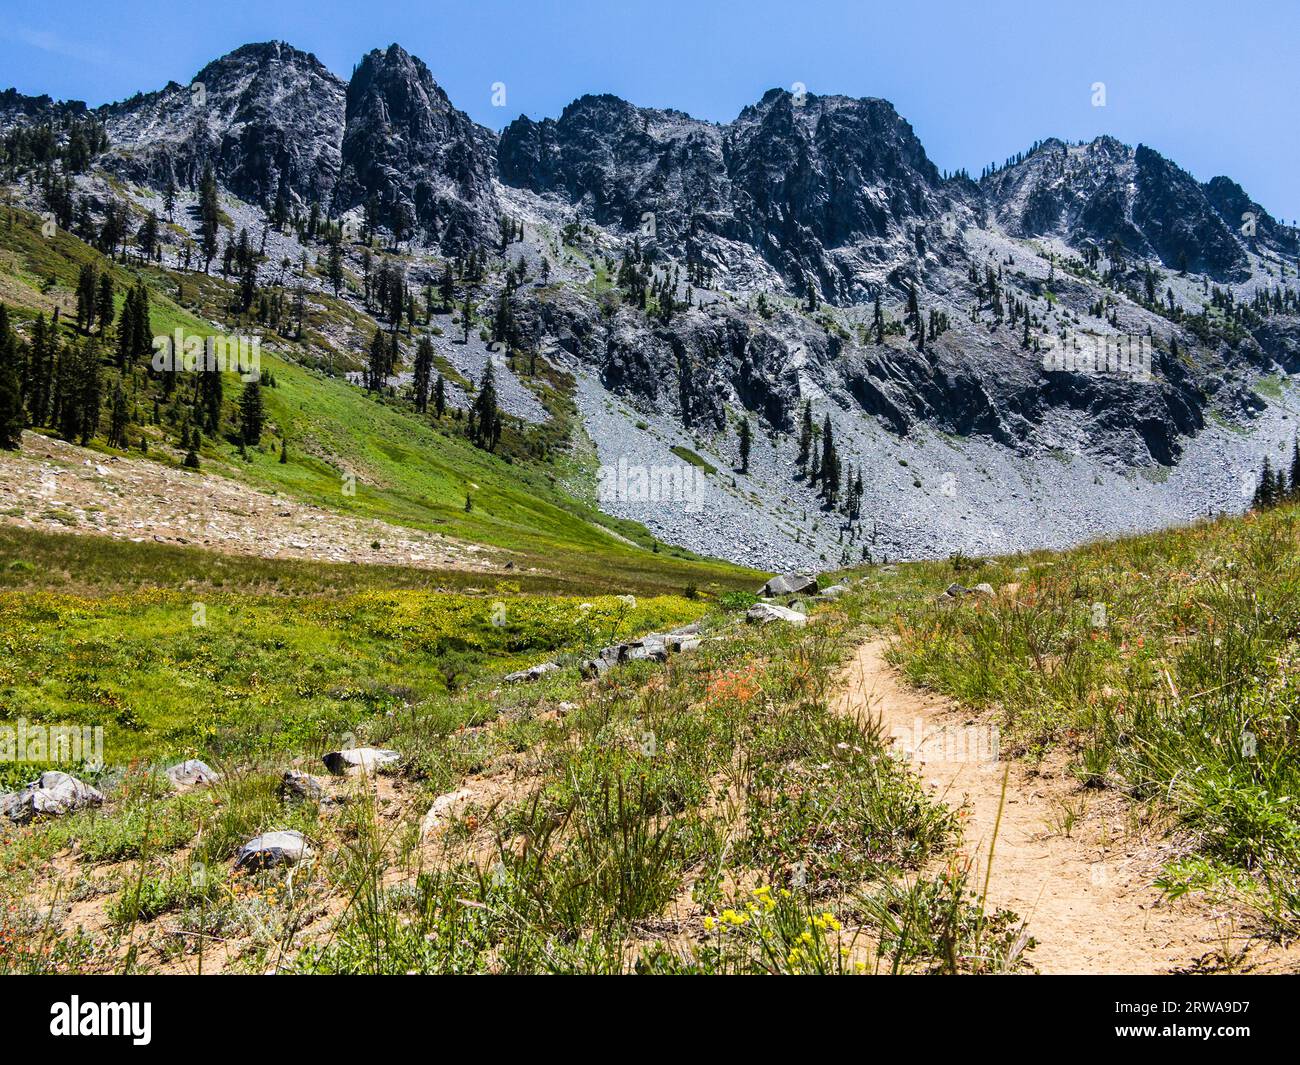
top-left (4, 44), bottom-right (1300, 567)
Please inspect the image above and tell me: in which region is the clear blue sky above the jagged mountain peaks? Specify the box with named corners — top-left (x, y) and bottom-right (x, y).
top-left (0, 0), bottom-right (1300, 220)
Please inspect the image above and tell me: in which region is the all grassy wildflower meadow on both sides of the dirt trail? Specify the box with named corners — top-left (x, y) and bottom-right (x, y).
top-left (10, 503), bottom-right (1300, 973)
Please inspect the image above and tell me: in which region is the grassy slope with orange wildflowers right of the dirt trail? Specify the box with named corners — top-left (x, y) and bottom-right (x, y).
top-left (871, 505), bottom-right (1300, 936)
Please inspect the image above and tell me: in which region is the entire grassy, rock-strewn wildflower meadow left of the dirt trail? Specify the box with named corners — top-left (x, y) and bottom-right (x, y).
top-left (0, 575), bottom-right (1013, 973)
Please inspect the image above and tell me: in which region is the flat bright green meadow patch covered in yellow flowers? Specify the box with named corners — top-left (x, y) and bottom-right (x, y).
top-left (0, 588), bottom-right (703, 783)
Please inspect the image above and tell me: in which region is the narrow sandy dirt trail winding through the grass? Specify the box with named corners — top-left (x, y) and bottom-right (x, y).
top-left (839, 641), bottom-right (1294, 973)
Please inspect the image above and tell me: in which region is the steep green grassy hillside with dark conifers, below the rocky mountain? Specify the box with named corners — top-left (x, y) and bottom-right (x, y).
top-left (0, 211), bottom-right (758, 592)
